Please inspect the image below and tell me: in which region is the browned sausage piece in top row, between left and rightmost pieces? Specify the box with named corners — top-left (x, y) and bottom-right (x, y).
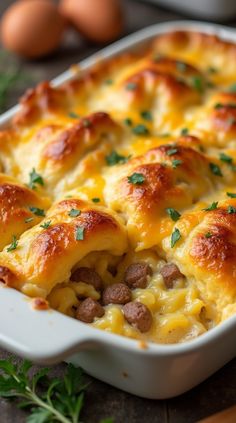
top-left (125, 263), bottom-right (152, 288)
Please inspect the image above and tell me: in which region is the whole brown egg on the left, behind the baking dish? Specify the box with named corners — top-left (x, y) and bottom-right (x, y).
top-left (0, 0), bottom-right (65, 58)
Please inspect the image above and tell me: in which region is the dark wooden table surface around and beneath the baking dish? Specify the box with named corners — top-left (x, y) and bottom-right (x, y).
top-left (0, 0), bottom-right (236, 423)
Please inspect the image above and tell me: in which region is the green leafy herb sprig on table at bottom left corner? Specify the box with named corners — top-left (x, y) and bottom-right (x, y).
top-left (0, 358), bottom-right (114, 423)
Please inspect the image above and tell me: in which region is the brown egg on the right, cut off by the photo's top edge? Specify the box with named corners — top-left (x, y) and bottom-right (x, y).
top-left (59, 0), bottom-right (123, 43)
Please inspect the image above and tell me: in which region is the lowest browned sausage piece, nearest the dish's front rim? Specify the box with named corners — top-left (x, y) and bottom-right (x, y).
top-left (123, 302), bottom-right (152, 332)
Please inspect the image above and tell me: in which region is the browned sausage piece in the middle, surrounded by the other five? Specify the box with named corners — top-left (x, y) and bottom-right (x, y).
top-left (102, 283), bottom-right (131, 305)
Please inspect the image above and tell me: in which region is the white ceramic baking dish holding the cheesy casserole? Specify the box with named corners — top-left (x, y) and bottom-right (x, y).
top-left (0, 21), bottom-right (236, 398)
